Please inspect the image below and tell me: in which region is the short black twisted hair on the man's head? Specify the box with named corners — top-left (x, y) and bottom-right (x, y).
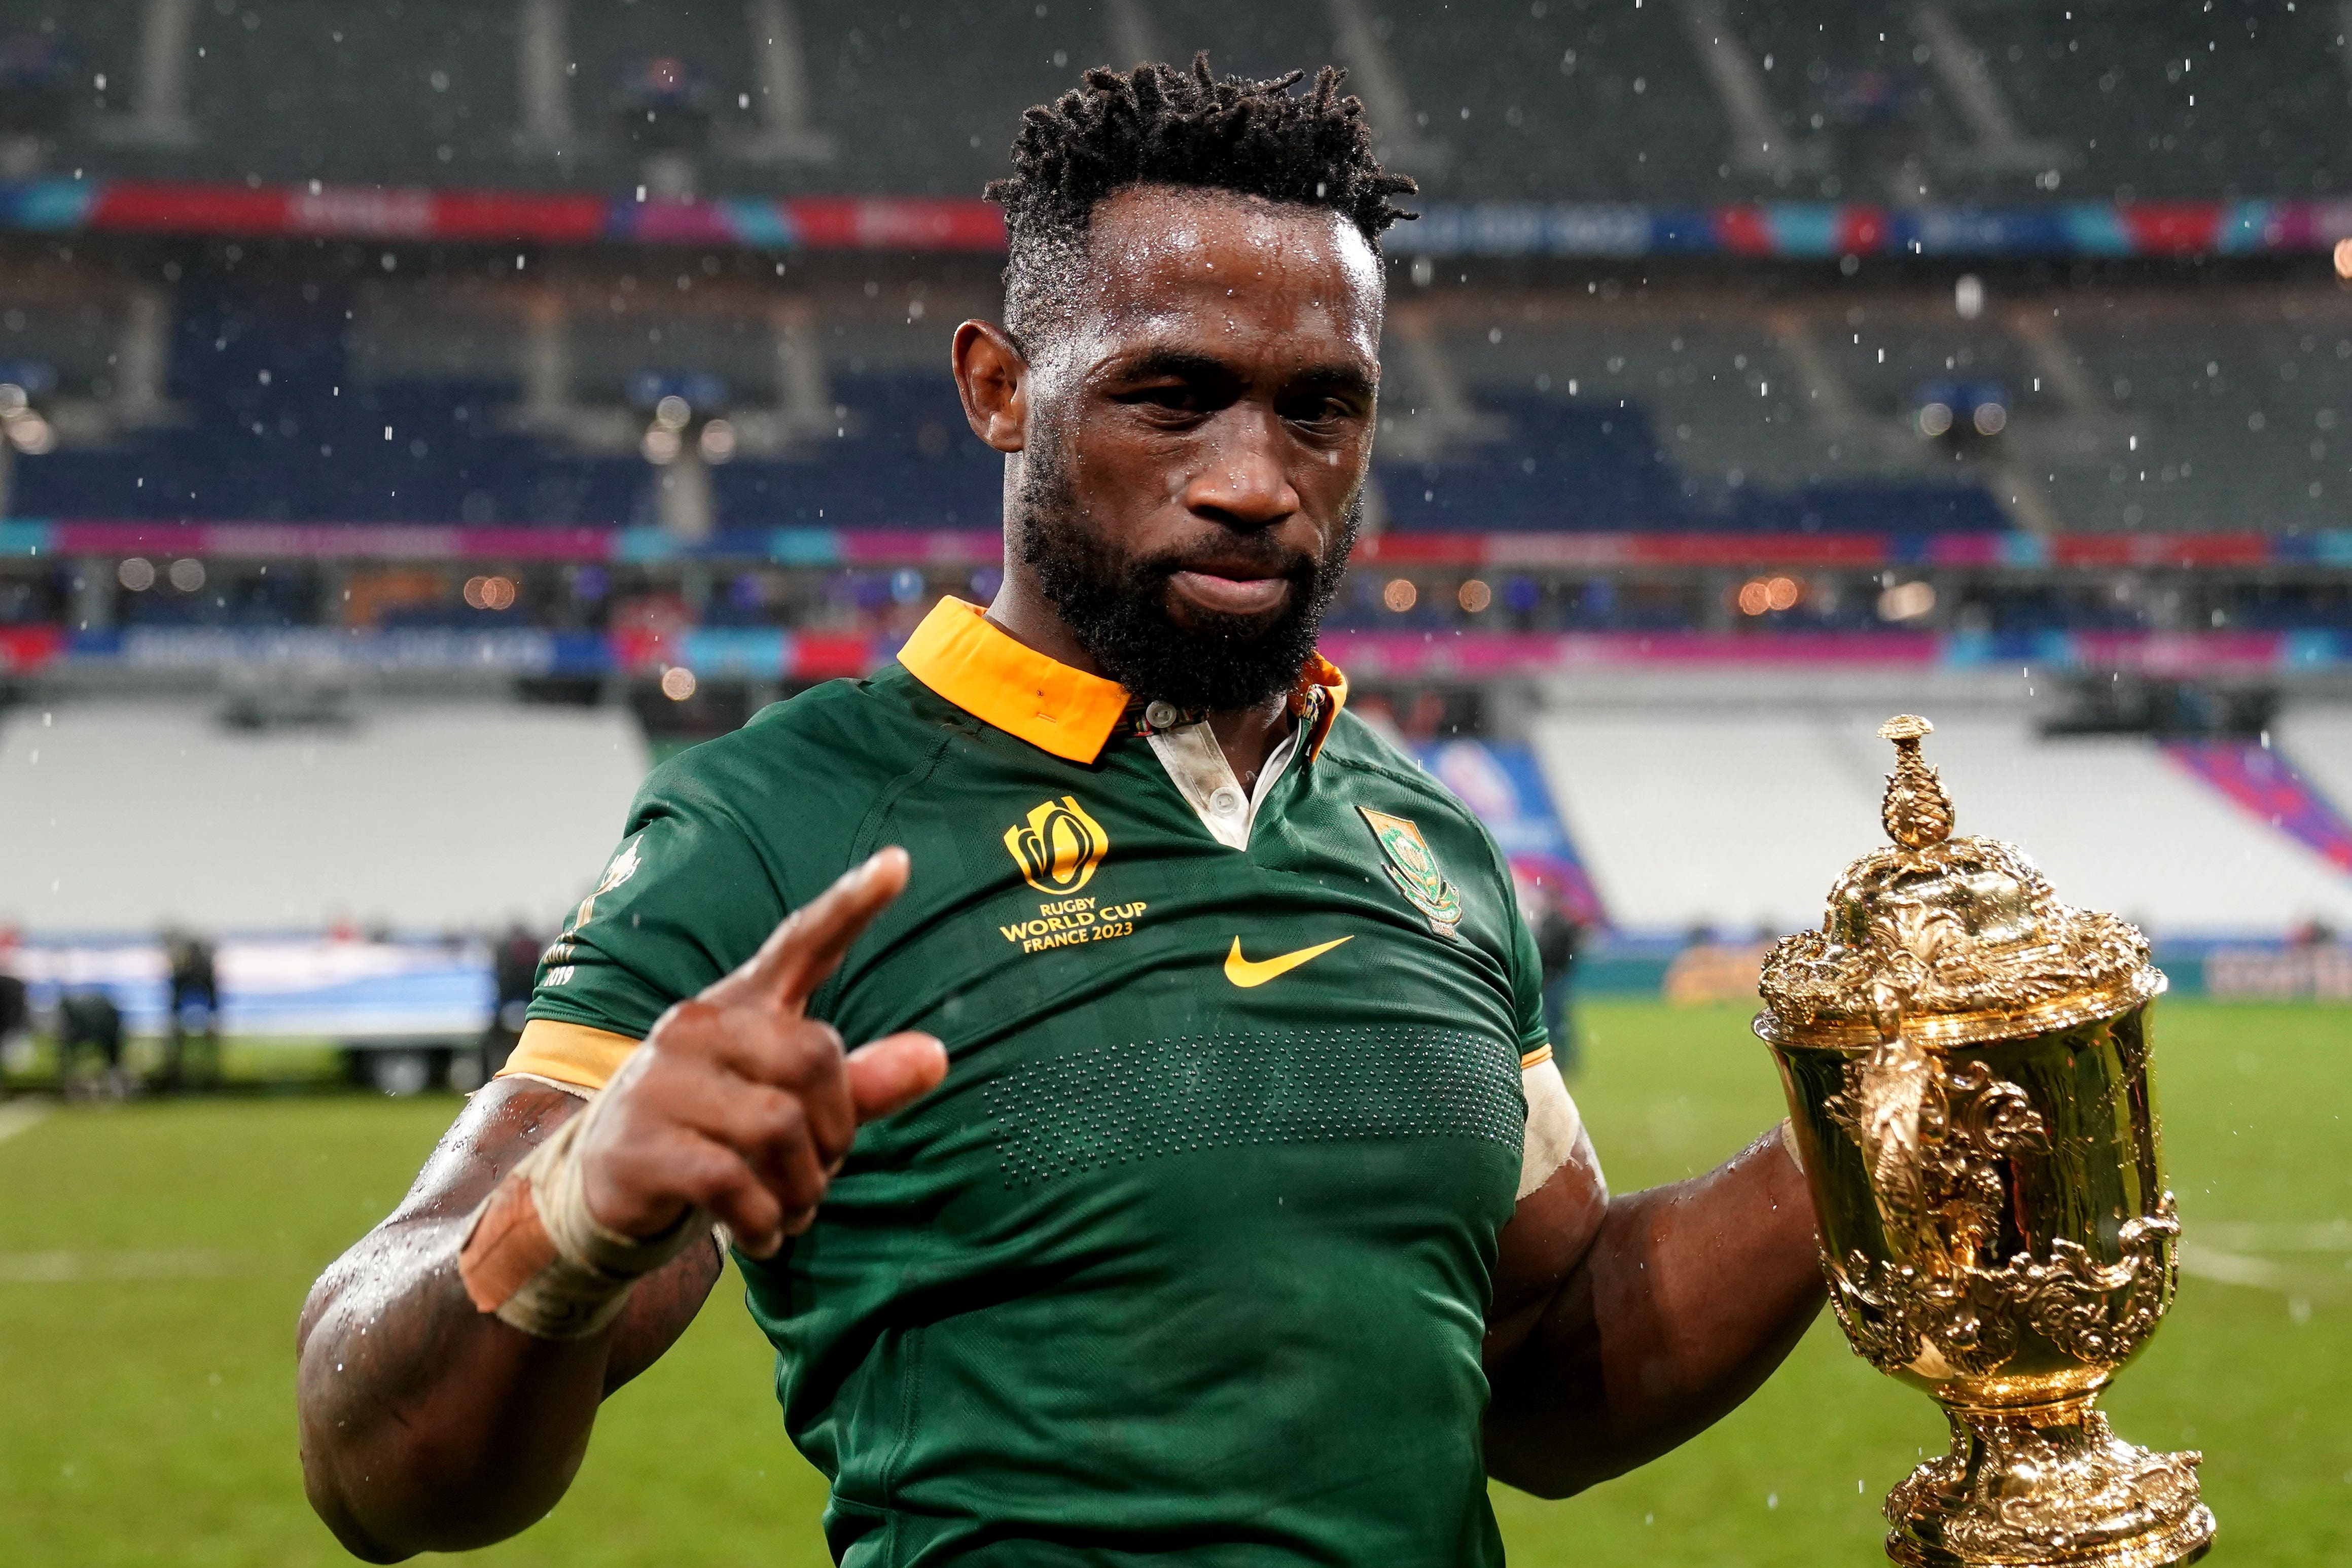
top-left (983, 49), bottom-right (1418, 348)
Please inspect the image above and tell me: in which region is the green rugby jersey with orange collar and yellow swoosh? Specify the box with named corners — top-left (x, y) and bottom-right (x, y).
top-left (524, 602), bottom-right (1574, 1568)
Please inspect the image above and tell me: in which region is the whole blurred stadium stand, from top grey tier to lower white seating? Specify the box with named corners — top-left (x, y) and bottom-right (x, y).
top-left (0, 0), bottom-right (2352, 959)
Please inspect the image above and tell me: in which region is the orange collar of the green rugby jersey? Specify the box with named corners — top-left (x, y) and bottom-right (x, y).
top-left (899, 597), bottom-right (1348, 762)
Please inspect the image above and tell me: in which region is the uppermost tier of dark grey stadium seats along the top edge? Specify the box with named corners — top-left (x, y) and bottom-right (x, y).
top-left (5, 0), bottom-right (2352, 202)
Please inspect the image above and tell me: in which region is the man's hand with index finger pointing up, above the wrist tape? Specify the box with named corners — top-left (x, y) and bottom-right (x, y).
top-left (581, 848), bottom-right (948, 1258)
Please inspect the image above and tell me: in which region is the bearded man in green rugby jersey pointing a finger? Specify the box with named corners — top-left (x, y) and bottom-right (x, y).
top-left (284, 61), bottom-right (1821, 1565)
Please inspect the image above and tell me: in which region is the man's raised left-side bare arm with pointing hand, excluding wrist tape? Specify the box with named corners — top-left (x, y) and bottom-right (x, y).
top-left (296, 851), bottom-right (948, 1561)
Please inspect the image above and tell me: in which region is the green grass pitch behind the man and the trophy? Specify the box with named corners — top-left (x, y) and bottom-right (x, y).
top-left (0, 1002), bottom-right (2352, 1568)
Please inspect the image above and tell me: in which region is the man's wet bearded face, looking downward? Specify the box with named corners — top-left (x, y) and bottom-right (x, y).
top-left (957, 186), bottom-right (1381, 707)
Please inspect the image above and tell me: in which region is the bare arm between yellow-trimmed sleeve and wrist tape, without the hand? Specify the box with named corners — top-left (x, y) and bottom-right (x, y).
top-left (296, 1079), bottom-right (720, 1563)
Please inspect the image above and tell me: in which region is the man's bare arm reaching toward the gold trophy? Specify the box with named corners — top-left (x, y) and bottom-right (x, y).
top-left (1486, 1133), bottom-right (1823, 1498)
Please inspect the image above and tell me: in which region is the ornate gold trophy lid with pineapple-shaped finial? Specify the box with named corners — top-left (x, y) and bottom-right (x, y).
top-left (1755, 712), bottom-right (2164, 1049)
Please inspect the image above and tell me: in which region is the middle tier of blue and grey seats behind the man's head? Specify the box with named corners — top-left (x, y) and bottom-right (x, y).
top-left (14, 256), bottom-right (2352, 533)
